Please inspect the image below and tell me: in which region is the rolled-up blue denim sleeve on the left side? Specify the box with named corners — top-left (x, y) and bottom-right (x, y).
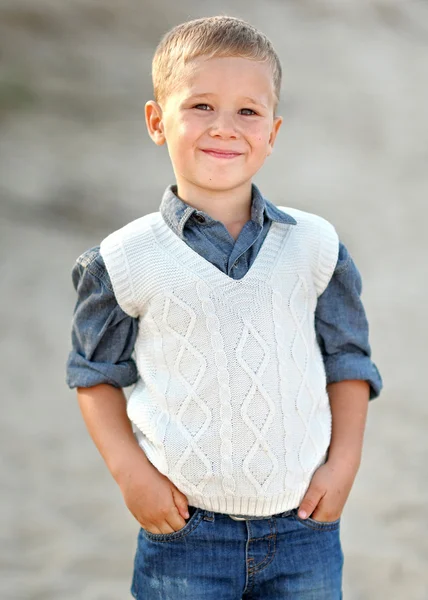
top-left (66, 246), bottom-right (138, 388)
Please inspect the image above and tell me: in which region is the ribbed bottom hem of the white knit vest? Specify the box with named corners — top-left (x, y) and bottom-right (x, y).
top-left (183, 482), bottom-right (309, 517)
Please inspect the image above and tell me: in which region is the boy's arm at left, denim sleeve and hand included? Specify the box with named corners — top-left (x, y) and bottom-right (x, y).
top-left (67, 248), bottom-right (188, 533)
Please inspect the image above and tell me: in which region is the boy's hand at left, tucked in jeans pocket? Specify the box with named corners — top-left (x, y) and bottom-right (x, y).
top-left (119, 454), bottom-right (189, 534)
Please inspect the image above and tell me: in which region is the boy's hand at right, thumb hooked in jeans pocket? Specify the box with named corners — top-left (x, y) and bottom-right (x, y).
top-left (298, 461), bottom-right (358, 522)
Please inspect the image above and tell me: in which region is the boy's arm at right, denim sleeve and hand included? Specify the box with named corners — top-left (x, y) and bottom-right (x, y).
top-left (299, 244), bottom-right (382, 521)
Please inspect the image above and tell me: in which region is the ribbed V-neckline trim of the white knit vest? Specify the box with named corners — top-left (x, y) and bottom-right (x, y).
top-left (158, 215), bottom-right (291, 285)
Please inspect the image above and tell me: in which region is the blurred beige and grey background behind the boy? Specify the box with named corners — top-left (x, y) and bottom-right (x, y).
top-left (0, 0), bottom-right (428, 600)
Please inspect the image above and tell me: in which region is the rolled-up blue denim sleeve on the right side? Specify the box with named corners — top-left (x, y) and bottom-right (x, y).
top-left (315, 243), bottom-right (382, 400)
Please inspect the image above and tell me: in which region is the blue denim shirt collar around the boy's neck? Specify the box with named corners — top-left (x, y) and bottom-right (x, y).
top-left (159, 183), bottom-right (297, 238)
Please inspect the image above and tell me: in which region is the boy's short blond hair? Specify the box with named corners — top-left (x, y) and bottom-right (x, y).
top-left (152, 16), bottom-right (282, 110)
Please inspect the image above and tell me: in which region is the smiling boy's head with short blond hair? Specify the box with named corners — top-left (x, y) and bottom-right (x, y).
top-left (146, 16), bottom-right (282, 202)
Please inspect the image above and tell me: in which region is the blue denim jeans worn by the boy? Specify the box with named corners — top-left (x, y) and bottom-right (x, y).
top-left (131, 507), bottom-right (343, 600)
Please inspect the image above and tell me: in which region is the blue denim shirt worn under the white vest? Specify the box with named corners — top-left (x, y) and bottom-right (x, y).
top-left (67, 184), bottom-right (382, 399)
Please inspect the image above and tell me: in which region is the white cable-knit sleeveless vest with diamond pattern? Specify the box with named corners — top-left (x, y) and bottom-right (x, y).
top-left (101, 207), bottom-right (339, 516)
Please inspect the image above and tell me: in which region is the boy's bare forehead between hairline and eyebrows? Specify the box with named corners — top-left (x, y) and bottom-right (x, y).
top-left (170, 57), bottom-right (274, 102)
